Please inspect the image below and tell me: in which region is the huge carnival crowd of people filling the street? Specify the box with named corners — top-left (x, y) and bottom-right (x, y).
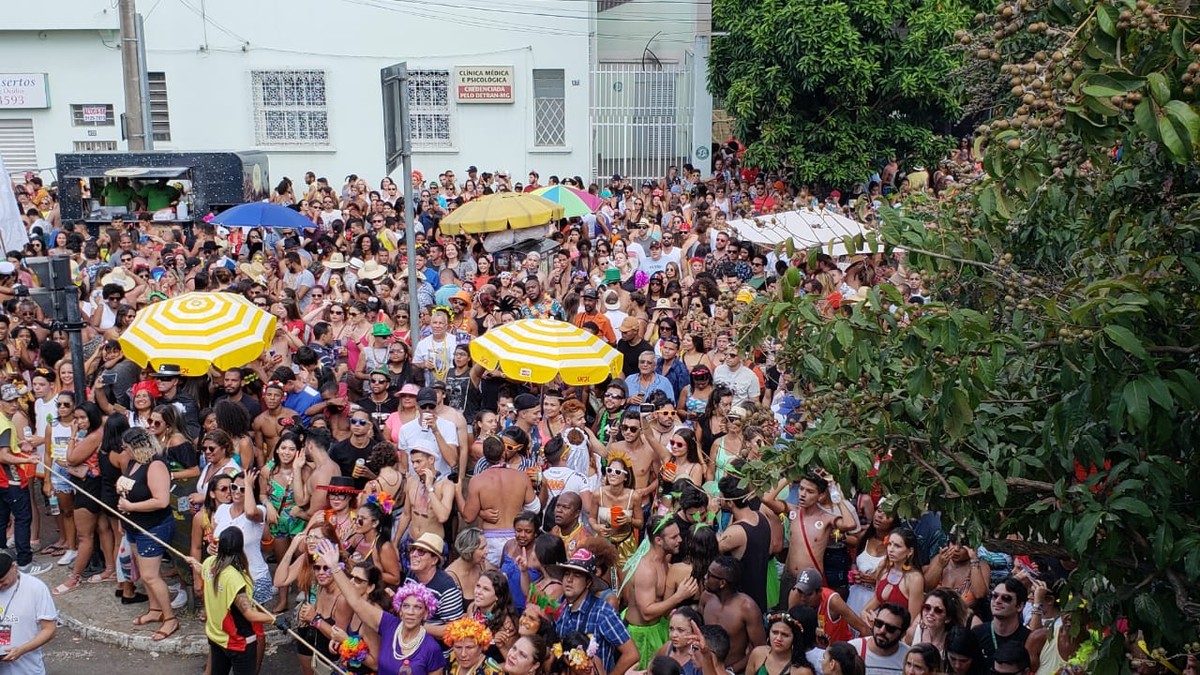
top-left (0, 147), bottom-right (1190, 675)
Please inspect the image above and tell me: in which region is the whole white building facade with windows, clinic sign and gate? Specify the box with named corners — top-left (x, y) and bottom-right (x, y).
top-left (0, 0), bottom-right (710, 184)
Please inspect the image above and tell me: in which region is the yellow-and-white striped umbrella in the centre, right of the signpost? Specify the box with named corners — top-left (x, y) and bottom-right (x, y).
top-left (470, 318), bottom-right (623, 387)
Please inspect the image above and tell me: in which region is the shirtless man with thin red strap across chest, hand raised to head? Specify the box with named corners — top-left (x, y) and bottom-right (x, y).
top-left (780, 470), bottom-right (860, 589)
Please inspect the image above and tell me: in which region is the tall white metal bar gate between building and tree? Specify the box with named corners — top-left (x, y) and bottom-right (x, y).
top-left (590, 64), bottom-right (692, 185)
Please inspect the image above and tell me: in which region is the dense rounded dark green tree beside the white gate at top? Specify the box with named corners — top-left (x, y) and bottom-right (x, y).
top-left (709, 0), bottom-right (976, 186)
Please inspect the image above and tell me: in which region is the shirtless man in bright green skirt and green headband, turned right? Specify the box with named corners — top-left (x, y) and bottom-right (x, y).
top-left (619, 511), bottom-right (697, 669)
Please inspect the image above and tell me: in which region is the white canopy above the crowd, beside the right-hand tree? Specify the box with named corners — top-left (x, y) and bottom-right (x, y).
top-left (728, 209), bottom-right (882, 256)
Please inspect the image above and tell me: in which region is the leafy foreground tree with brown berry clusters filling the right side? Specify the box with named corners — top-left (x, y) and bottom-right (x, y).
top-left (749, 0), bottom-right (1200, 673)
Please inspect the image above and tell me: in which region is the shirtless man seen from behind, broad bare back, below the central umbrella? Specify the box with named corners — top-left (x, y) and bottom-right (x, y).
top-left (455, 436), bottom-right (541, 567)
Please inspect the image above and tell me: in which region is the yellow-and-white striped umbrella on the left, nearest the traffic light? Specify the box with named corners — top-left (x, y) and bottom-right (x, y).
top-left (120, 292), bottom-right (275, 376)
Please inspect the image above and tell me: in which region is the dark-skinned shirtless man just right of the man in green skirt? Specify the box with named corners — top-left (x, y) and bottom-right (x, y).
top-left (700, 555), bottom-right (767, 673)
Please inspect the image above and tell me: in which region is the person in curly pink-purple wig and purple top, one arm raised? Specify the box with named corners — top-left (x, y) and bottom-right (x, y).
top-left (317, 542), bottom-right (446, 675)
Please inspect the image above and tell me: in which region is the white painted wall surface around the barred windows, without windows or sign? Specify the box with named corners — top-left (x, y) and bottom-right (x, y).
top-left (0, 0), bottom-right (590, 183)
